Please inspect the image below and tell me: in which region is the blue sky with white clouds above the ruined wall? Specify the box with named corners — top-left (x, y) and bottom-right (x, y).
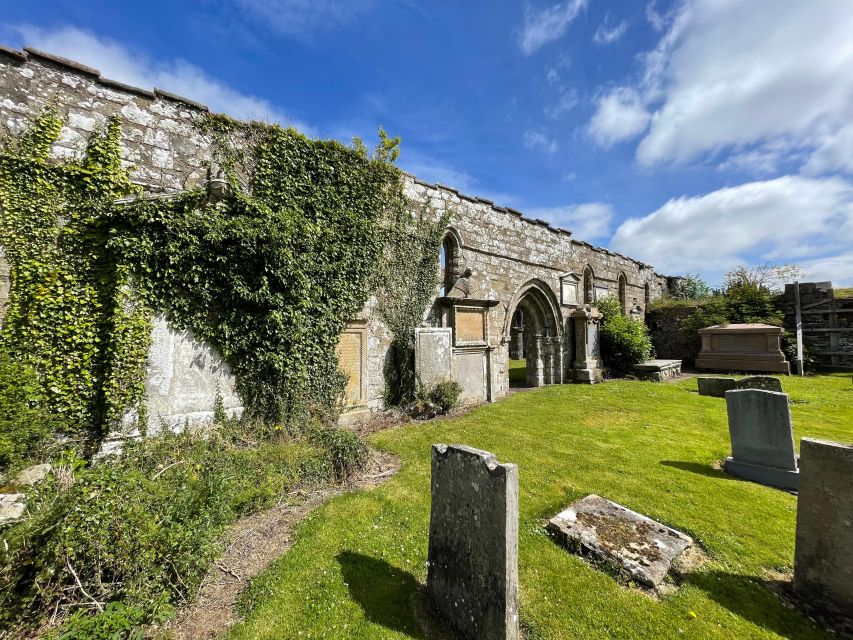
top-left (0, 0), bottom-right (853, 286)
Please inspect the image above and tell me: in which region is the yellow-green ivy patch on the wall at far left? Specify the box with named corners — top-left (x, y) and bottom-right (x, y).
top-left (0, 108), bottom-right (150, 444)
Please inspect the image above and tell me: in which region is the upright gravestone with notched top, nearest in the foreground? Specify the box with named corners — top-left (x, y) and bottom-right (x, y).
top-left (427, 444), bottom-right (518, 640)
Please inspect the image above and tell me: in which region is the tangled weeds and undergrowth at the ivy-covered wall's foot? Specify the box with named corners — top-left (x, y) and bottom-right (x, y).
top-left (0, 422), bottom-right (344, 637)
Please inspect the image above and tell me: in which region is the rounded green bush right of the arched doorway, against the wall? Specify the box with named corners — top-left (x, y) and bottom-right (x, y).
top-left (596, 298), bottom-right (652, 372)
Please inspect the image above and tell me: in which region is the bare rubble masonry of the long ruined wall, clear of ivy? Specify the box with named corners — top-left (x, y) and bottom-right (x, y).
top-left (0, 47), bottom-right (667, 421)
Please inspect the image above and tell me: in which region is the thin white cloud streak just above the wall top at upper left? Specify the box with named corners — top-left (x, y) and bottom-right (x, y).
top-left (16, 26), bottom-right (316, 135)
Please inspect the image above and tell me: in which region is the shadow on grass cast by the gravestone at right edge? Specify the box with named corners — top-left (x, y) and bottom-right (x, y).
top-left (682, 571), bottom-right (821, 640)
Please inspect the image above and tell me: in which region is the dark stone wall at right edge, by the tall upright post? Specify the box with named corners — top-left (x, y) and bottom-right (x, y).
top-left (783, 282), bottom-right (853, 369)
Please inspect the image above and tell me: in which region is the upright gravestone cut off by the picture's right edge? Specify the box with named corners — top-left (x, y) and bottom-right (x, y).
top-left (794, 438), bottom-right (853, 618)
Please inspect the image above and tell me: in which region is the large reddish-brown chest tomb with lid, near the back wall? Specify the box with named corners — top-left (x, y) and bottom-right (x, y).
top-left (696, 324), bottom-right (791, 374)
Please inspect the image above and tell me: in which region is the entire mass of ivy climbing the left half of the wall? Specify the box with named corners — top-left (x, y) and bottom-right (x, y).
top-left (0, 109), bottom-right (446, 450)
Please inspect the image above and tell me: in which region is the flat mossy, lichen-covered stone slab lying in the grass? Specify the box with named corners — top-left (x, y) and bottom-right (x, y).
top-left (547, 494), bottom-right (693, 587)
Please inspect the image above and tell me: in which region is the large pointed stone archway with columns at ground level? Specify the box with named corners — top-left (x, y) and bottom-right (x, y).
top-left (503, 279), bottom-right (563, 387)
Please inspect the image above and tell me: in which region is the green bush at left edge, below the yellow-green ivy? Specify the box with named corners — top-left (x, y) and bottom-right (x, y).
top-left (0, 351), bottom-right (60, 471)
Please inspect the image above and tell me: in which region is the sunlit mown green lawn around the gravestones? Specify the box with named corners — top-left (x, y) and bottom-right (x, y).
top-left (229, 374), bottom-right (853, 640)
